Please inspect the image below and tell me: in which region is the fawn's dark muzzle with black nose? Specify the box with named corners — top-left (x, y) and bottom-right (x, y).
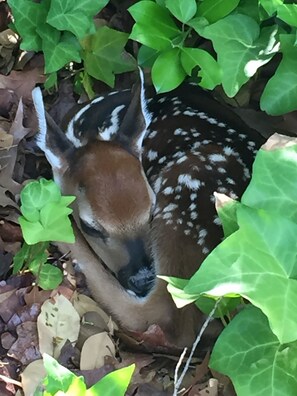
top-left (117, 239), bottom-right (156, 297)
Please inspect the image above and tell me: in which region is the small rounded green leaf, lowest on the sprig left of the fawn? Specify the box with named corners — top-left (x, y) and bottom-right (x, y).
top-left (29, 260), bottom-right (63, 290)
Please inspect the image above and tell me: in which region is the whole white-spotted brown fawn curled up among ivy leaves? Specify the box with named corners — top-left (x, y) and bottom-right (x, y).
top-left (33, 71), bottom-right (263, 346)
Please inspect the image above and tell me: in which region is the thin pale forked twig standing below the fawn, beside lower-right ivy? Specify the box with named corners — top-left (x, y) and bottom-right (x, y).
top-left (173, 298), bottom-right (222, 396)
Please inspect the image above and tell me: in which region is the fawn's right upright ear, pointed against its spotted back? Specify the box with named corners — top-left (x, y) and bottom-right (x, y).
top-left (115, 68), bottom-right (151, 159)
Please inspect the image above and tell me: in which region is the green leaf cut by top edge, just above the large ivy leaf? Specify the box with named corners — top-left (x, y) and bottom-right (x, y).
top-left (195, 0), bottom-right (240, 23)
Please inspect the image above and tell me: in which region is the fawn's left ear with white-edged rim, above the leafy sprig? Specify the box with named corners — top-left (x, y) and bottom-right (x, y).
top-left (32, 87), bottom-right (73, 170)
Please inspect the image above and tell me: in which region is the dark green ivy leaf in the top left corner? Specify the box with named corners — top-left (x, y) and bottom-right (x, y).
top-left (8, 0), bottom-right (49, 52)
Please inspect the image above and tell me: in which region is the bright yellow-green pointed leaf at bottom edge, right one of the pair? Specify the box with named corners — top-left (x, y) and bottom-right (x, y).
top-left (86, 364), bottom-right (135, 396)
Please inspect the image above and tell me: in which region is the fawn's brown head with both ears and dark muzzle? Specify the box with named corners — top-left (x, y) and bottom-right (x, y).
top-left (32, 71), bottom-right (155, 296)
